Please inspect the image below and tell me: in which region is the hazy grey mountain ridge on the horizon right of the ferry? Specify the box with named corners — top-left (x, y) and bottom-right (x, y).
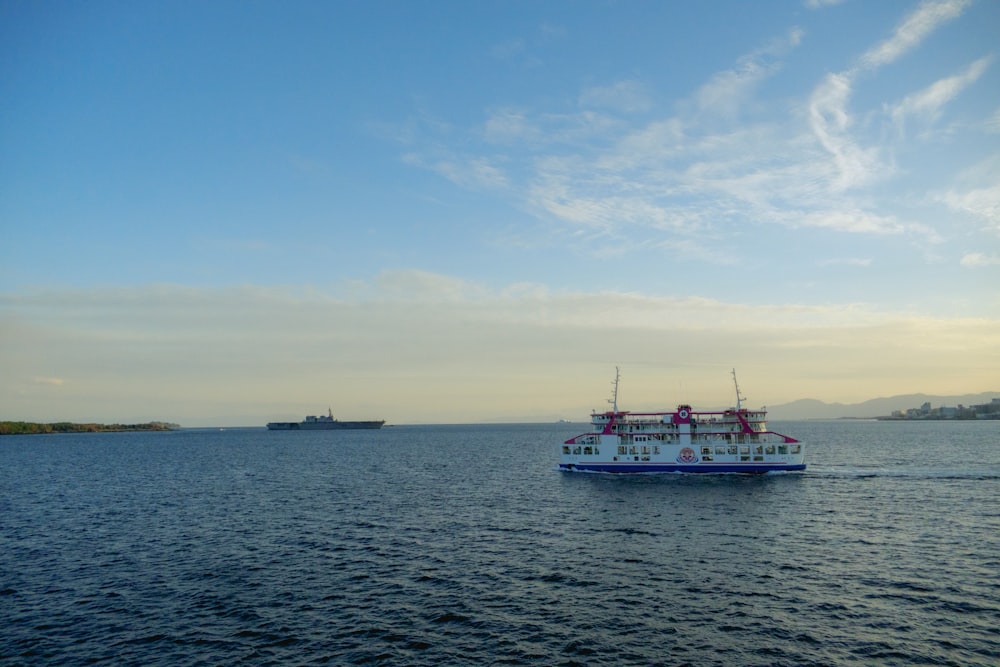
top-left (767, 391), bottom-right (1000, 420)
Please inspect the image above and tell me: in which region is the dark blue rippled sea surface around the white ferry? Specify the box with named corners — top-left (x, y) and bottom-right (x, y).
top-left (0, 421), bottom-right (1000, 665)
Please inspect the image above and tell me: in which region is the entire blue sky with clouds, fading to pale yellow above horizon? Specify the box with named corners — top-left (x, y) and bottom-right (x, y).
top-left (0, 0), bottom-right (1000, 425)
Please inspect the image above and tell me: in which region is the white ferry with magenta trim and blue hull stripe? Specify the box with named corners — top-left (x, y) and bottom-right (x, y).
top-left (559, 368), bottom-right (806, 474)
